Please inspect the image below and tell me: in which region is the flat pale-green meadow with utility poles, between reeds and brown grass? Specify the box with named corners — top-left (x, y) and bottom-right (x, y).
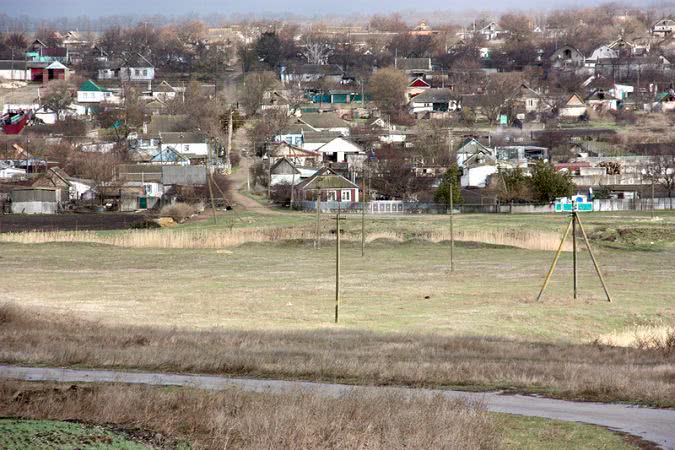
top-left (0, 236), bottom-right (675, 342)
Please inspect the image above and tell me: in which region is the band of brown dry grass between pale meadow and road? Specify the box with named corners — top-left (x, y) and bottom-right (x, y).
top-left (0, 306), bottom-right (675, 407)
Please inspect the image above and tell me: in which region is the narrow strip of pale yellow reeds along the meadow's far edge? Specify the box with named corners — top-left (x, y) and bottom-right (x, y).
top-left (0, 227), bottom-right (571, 251)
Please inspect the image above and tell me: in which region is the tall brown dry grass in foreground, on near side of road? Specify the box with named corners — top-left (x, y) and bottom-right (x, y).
top-left (0, 382), bottom-right (501, 450)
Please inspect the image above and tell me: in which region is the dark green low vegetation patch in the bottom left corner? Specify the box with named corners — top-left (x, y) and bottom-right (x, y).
top-left (0, 419), bottom-right (151, 450)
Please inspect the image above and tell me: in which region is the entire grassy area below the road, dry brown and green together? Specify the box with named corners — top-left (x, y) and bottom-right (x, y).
top-left (0, 382), bottom-right (638, 450)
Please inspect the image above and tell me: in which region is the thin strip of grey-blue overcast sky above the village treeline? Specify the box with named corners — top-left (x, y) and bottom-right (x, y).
top-left (21, 0), bottom-right (597, 18)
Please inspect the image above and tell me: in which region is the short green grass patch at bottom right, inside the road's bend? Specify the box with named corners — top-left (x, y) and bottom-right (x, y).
top-left (498, 414), bottom-right (638, 450)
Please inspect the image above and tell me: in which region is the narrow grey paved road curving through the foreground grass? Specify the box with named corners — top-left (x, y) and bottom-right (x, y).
top-left (0, 365), bottom-right (675, 449)
